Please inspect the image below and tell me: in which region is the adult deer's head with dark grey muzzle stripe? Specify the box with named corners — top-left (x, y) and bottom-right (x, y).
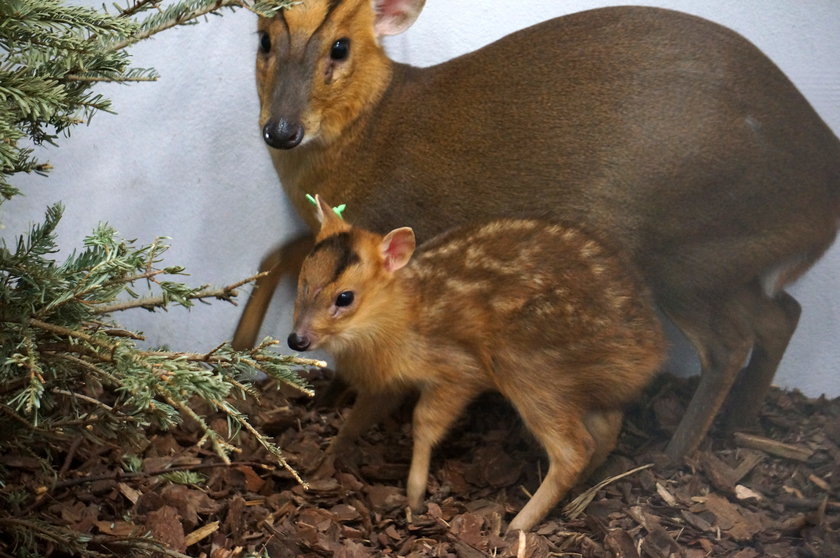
top-left (256, 0), bottom-right (425, 149)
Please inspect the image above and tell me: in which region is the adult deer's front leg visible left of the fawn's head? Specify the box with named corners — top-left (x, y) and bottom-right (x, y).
top-left (232, 235), bottom-right (313, 350)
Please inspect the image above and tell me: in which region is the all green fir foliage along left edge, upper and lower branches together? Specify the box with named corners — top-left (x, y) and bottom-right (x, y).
top-left (0, 0), bottom-right (308, 556)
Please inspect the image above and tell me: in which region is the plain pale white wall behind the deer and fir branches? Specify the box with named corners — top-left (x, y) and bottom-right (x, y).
top-left (0, 0), bottom-right (840, 395)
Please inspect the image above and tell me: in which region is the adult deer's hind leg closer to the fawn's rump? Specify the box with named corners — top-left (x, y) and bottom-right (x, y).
top-left (665, 291), bottom-right (754, 460)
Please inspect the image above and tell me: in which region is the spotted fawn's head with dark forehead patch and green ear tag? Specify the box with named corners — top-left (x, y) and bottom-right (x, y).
top-left (288, 196), bottom-right (415, 351)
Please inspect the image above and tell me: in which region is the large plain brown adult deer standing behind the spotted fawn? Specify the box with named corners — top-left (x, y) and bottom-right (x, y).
top-left (234, 0), bottom-right (840, 464)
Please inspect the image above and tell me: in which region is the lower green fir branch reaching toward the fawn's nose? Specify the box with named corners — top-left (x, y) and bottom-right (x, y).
top-left (0, 217), bottom-right (318, 470)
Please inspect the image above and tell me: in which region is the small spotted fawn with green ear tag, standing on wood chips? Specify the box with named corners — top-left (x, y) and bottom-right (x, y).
top-left (289, 198), bottom-right (665, 529)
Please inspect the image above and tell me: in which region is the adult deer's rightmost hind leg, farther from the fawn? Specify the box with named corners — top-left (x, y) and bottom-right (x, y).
top-left (724, 291), bottom-right (802, 432)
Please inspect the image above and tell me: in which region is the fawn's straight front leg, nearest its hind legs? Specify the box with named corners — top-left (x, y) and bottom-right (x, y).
top-left (406, 379), bottom-right (480, 512)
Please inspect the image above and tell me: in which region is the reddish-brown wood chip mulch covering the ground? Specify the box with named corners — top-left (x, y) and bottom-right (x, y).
top-left (0, 372), bottom-right (840, 558)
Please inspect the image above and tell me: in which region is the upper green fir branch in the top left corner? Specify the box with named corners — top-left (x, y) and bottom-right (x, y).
top-left (0, 0), bottom-right (295, 204)
